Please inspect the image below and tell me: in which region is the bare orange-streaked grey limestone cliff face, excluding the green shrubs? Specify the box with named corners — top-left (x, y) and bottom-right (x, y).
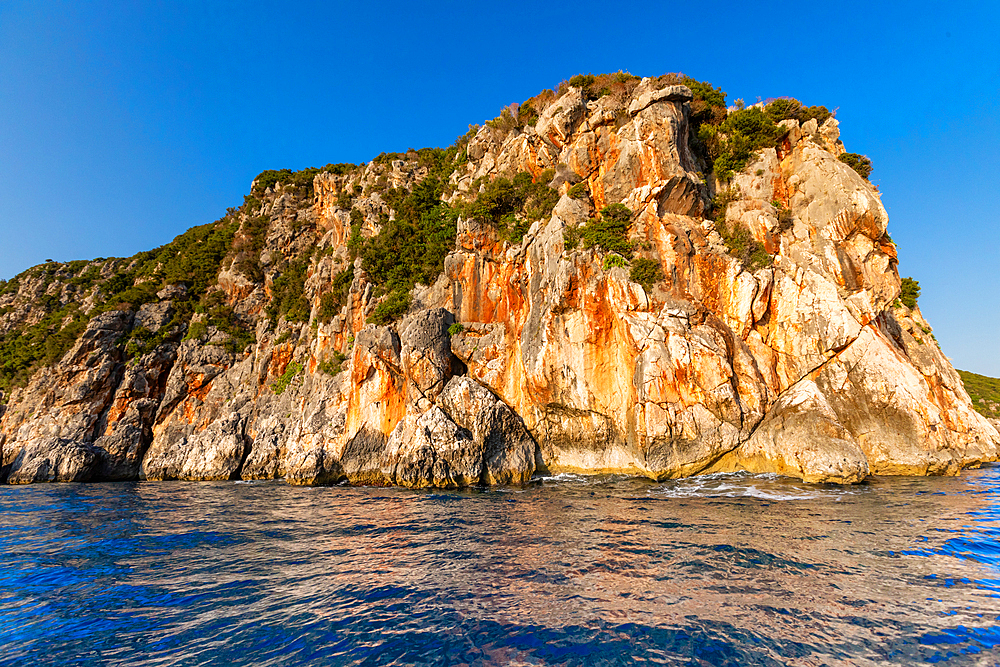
top-left (0, 80), bottom-right (1000, 487)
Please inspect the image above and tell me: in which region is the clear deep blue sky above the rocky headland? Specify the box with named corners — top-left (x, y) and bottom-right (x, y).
top-left (0, 0), bottom-right (1000, 376)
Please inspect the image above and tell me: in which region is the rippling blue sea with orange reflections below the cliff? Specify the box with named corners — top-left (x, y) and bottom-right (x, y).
top-left (0, 467), bottom-right (1000, 666)
